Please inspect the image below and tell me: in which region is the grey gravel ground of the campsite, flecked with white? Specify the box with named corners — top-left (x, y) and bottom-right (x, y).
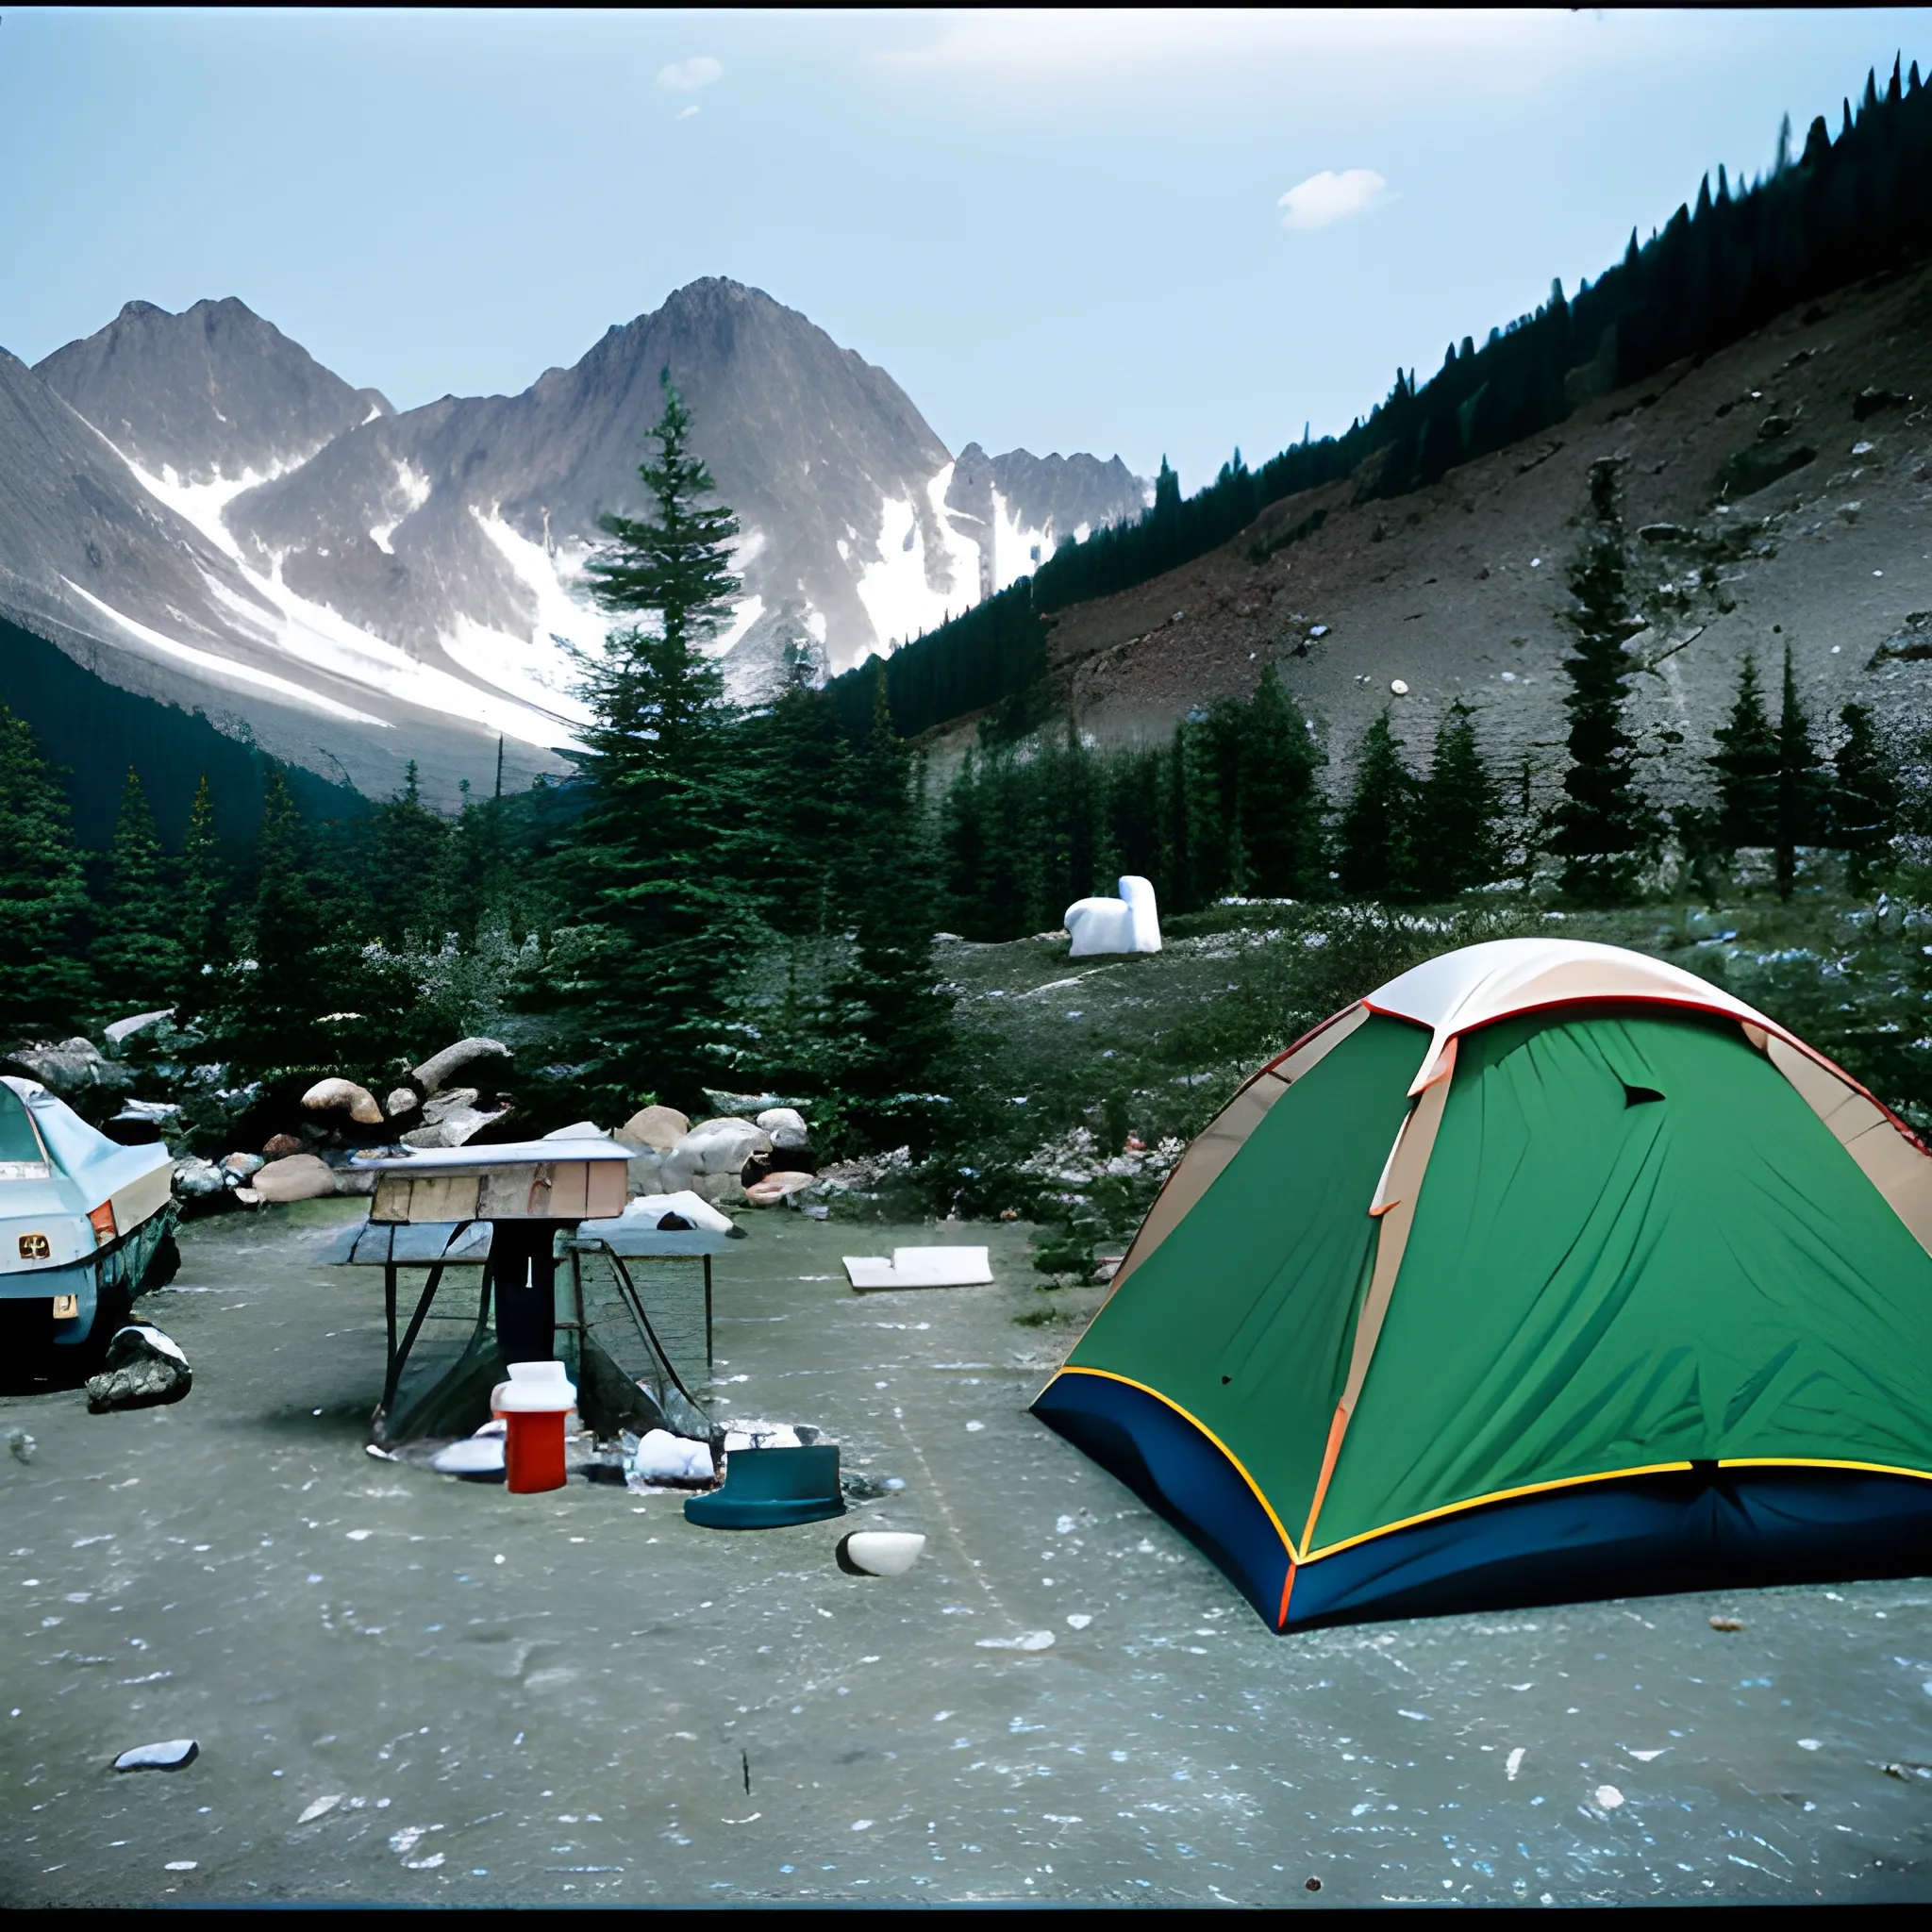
top-left (0, 1204), bottom-right (1932, 1905)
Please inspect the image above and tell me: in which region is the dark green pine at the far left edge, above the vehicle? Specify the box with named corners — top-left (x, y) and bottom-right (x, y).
top-left (0, 706), bottom-right (92, 1047)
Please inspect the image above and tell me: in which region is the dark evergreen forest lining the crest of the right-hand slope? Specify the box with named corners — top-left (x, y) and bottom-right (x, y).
top-left (833, 62), bottom-right (1932, 736)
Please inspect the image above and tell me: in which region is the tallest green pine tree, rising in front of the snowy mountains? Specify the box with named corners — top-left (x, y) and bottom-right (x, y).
top-left (535, 369), bottom-right (754, 1108)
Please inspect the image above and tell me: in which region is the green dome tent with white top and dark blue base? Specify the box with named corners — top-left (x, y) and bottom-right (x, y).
top-left (1034, 939), bottom-right (1932, 1631)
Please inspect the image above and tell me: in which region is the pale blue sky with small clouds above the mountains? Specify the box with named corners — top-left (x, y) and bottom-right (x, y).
top-left (0, 8), bottom-right (1932, 489)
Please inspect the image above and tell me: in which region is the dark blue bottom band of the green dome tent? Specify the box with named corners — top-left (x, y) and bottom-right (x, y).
top-left (1034, 1374), bottom-right (1932, 1631)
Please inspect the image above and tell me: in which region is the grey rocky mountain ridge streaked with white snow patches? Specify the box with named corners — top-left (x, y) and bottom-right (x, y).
top-left (0, 278), bottom-right (1145, 802)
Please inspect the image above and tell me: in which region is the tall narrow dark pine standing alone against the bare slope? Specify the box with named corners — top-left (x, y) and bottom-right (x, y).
top-left (1552, 458), bottom-right (1657, 904)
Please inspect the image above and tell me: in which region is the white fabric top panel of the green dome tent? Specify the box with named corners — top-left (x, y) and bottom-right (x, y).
top-left (1362, 939), bottom-right (1785, 1093)
